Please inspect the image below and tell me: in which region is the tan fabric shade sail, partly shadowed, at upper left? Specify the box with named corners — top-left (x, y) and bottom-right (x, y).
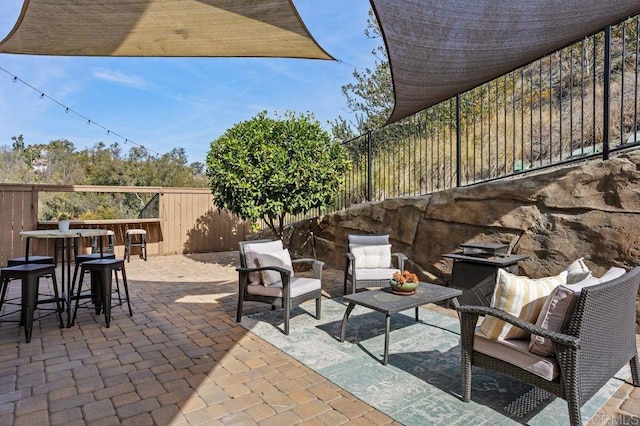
top-left (0, 0), bottom-right (332, 59)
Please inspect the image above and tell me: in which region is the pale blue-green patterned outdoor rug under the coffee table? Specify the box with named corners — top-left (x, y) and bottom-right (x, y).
top-left (241, 298), bottom-right (630, 426)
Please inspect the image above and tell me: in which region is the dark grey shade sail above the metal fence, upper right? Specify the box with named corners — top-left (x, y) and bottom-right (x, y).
top-left (371, 0), bottom-right (640, 123)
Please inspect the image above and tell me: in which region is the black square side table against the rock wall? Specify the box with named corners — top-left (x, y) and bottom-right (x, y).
top-left (442, 253), bottom-right (528, 306)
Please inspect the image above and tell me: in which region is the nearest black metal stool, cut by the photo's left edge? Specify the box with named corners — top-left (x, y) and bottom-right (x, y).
top-left (0, 263), bottom-right (64, 343)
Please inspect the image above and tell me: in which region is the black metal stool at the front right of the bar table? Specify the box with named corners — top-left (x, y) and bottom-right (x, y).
top-left (69, 258), bottom-right (133, 328)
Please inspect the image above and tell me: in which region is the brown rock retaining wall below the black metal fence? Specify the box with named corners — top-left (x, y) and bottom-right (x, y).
top-left (287, 150), bottom-right (640, 322)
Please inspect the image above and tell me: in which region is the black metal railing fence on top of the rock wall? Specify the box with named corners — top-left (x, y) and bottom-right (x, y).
top-left (292, 16), bottom-right (640, 225)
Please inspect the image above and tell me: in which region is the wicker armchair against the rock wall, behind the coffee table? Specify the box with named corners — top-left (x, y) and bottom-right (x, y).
top-left (344, 234), bottom-right (407, 294)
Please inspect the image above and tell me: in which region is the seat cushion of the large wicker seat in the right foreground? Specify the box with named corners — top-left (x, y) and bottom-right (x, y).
top-left (473, 334), bottom-right (560, 380)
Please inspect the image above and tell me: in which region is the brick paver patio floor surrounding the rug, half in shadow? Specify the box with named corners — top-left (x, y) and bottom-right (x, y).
top-left (0, 252), bottom-right (640, 426)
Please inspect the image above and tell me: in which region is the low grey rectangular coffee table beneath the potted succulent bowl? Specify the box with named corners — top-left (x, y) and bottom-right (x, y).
top-left (340, 282), bottom-right (462, 365)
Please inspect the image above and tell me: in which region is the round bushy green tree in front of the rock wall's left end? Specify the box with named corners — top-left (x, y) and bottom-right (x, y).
top-left (207, 111), bottom-right (349, 238)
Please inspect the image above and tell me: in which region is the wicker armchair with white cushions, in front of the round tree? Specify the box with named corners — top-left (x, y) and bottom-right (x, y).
top-left (236, 240), bottom-right (324, 335)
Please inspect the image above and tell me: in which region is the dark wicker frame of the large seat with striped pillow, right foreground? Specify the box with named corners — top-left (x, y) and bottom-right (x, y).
top-left (459, 267), bottom-right (640, 425)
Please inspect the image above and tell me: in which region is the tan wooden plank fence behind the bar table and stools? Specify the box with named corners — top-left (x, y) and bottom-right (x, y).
top-left (0, 184), bottom-right (251, 266)
